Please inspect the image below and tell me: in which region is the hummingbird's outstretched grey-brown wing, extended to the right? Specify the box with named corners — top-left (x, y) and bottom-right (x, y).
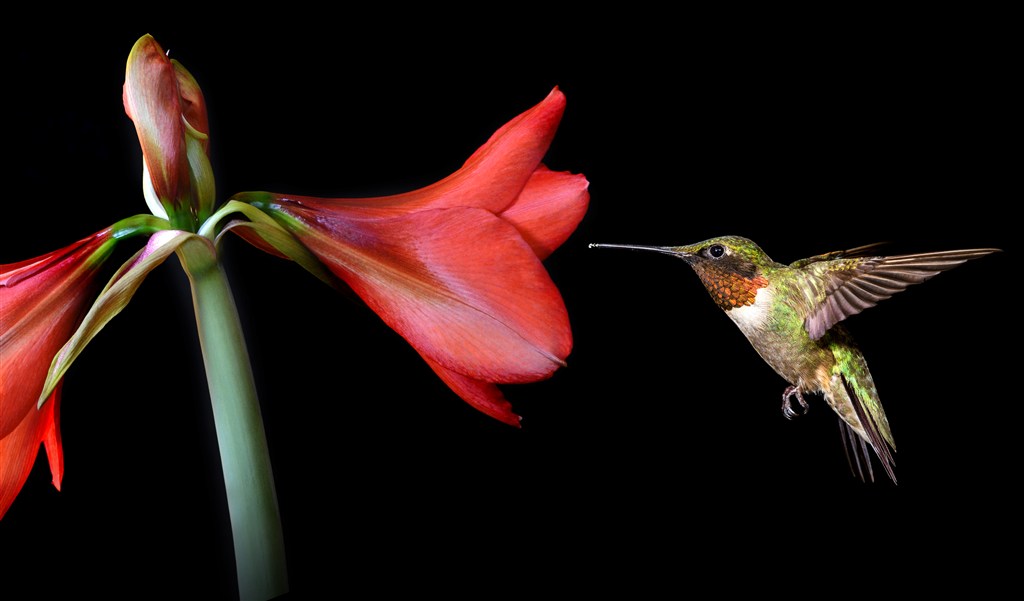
top-left (791, 245), bottom-right (999, 340)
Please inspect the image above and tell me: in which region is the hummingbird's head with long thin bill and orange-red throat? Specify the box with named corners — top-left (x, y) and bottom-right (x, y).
top-left (590, 235), bottom-right (772, 310)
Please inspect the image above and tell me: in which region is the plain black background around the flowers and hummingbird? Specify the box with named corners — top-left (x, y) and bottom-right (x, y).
top-left (0, 11), bottom-right (1020, 599)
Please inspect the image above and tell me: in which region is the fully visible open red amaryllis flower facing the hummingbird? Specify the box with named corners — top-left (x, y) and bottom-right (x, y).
top-left (234, 88), bottom-right (589, 426)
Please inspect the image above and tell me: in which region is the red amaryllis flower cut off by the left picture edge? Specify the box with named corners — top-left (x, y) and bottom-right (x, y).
top-left (0, 229), bottom-right (112, 518)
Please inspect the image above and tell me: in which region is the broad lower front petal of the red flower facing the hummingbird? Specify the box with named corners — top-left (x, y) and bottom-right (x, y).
top-left (288, 206), bottom-right (572, 382)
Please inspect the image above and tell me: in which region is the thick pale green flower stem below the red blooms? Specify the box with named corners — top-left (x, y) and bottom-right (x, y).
top-left (178, 239), bottom-right (288, 601)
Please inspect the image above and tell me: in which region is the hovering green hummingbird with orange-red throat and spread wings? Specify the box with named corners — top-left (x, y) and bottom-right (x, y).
top-left (590, 235), bottom-right (999, 484)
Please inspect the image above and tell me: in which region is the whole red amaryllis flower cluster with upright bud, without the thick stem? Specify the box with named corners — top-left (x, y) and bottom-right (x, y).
top-left (0, 36), bottom-right (589, 565)
